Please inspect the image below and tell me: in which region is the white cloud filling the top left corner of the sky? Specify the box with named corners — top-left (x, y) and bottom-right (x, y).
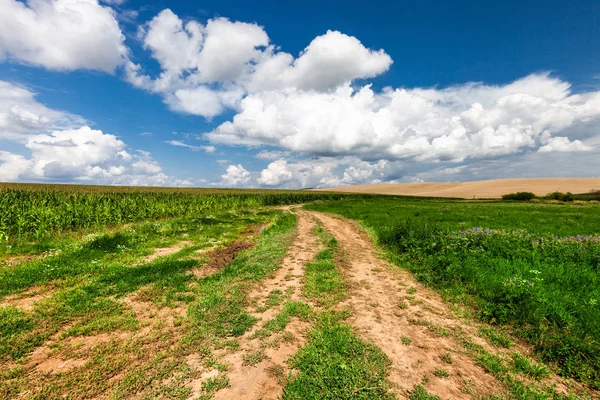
top-left (0, 0), bottom-right (127, 73)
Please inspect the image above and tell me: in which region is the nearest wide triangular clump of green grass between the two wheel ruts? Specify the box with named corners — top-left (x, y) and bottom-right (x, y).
top-left (283, 313), bottom-right (395, 400)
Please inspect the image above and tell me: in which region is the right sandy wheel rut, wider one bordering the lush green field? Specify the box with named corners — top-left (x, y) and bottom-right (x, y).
top-left (311, 212), bottom-right (504, 399)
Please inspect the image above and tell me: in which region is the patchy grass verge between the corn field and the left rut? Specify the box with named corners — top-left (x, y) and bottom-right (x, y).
top-left (0, 210), bottom-right (301, 399)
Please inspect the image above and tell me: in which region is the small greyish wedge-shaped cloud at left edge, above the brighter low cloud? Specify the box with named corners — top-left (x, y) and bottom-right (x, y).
top-left (0, 81), bottom-right (85, 140)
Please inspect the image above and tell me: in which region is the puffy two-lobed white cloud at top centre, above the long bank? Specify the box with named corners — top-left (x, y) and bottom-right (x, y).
top-left (125, 9), bottom-right (392, 118)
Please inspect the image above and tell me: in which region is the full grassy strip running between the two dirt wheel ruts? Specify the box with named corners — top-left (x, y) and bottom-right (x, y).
top-left (283, 221), bottom-right (395, 399)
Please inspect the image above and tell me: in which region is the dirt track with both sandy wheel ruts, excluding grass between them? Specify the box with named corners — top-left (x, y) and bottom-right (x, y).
top-left (199, 209), bottom-right (580, 399)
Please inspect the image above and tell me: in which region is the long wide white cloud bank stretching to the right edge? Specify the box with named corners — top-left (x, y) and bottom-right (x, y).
top-left (206, 74), bottom-right (600, 162)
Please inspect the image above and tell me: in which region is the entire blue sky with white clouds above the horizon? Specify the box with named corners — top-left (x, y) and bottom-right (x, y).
top-left (0, 0), bottom-right (600, 188)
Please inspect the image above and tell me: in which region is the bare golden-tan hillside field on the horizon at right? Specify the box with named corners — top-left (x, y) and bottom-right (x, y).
top-left (318, 178), bottom-right (600, 199)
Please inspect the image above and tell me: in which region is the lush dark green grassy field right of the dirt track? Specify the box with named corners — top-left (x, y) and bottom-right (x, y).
top-left (307, 198), bottom-right (600, 388)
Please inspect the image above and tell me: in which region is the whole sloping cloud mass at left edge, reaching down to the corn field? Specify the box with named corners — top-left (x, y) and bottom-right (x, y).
top-left (0, 81), bottom-right (193, 186)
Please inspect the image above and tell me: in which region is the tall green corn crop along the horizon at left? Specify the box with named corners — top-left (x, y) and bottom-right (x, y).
top-left (0, 184), bottom-right (356, 241)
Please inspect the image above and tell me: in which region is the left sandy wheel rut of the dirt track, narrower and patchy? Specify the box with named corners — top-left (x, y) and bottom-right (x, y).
top-left (189, 211), bottom-right (322, 400)
